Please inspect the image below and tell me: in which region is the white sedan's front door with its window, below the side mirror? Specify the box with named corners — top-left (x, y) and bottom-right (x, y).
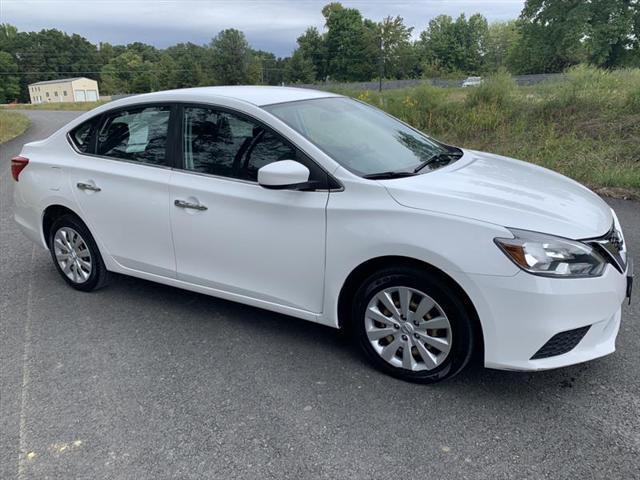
top-left (170, 106), bottom-right (329, 313)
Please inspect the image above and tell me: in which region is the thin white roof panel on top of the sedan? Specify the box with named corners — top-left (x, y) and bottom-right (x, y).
top-left (119, 85), bottom-right (340, 107)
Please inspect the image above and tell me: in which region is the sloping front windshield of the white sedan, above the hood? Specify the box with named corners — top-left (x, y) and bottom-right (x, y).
top-left (264, 97), bottom-right (455, 176)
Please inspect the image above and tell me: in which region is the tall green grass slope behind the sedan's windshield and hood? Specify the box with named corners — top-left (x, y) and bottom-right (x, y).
top-left (341, 66), bottom-right (640, 198)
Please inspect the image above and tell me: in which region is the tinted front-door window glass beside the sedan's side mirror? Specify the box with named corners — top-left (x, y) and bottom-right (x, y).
top-left (183, 107), bottom-right (296, 181)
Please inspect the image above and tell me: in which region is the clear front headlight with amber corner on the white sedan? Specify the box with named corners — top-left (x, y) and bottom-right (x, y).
top-left (495, 229), bottom-right (607, 278)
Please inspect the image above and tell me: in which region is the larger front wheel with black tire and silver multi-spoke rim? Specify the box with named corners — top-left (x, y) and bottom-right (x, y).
top-left (351, 267), bottom-right (476, 384)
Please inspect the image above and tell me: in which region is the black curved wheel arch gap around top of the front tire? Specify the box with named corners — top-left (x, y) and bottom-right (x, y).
top-left (338, 256), bottom-right (484, 356)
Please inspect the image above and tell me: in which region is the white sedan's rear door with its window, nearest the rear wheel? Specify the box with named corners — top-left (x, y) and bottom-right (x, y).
top-left (70, 105), bottom-right (175, 277)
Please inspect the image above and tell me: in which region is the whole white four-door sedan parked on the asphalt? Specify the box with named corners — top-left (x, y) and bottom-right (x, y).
top-left (11, 87), bottom-right (631, 383)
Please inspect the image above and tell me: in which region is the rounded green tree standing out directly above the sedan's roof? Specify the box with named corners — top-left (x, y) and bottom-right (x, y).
top-left (210, 28), bottom-right (259, 85)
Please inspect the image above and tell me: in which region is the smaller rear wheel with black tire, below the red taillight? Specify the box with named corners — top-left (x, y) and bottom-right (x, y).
top-left (48, 214), bottom-right (109, 292)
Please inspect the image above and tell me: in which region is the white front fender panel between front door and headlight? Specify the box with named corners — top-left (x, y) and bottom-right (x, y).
top-left (321, 180), bottom-right (519, 326)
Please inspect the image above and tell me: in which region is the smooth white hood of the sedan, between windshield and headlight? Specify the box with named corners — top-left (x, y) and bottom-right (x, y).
top-left (381, 150), bottom-right (613, 239)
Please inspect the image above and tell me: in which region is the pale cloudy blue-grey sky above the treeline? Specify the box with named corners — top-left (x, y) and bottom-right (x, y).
top-left (0, 0), bottom-right (524, 56)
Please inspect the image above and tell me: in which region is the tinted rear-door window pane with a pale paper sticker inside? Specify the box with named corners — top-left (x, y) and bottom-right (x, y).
top-left (96, 107), bottom-right (170, 165)
